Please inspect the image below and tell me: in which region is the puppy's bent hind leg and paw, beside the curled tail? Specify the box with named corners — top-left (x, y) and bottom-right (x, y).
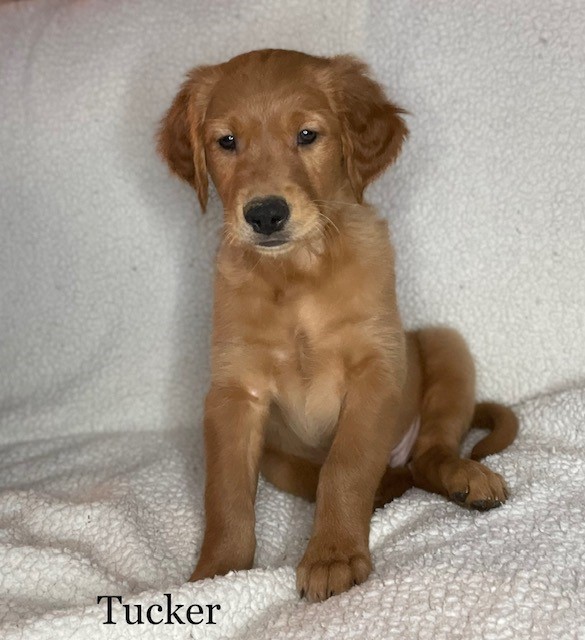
top-left (411, 328), bottom-right (516, 510)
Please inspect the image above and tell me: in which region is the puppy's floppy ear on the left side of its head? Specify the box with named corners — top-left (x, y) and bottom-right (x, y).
top-left (157, 67), bottom-right (219, 212)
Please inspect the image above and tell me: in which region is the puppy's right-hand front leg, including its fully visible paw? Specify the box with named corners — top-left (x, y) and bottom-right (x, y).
top-left (297, 361), bottom-right (400, 602)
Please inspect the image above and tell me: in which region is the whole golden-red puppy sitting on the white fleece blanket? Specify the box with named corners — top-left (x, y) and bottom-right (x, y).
top-left (158, 50), bottom-right (517, 601)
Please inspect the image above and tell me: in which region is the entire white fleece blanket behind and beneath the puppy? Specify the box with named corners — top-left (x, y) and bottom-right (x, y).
top-left (0, 0), bottom-right (585, 640)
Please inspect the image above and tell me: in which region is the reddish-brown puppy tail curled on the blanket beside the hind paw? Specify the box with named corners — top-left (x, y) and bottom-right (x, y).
top-left (470, 402), bottom-right (518, 460)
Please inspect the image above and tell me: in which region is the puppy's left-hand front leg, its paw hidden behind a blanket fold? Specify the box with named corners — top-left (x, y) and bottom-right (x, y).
top-left (191, 386), bottom-right (268, 581)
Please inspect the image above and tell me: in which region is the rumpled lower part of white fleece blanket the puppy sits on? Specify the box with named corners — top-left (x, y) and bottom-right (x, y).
top-left (0, 390), bottom-right (585, 640)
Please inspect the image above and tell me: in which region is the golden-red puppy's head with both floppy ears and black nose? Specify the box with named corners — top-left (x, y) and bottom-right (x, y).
top-left (158, 50), bottom-right (407, 254)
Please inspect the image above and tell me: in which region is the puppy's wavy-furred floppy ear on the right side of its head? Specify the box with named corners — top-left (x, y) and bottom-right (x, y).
top-left (331, 56), bottom-right (408, 202)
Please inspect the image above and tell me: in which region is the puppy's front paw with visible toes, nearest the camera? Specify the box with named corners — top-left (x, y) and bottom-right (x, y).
top-left (297, 538), bottom-right (372, 602)
